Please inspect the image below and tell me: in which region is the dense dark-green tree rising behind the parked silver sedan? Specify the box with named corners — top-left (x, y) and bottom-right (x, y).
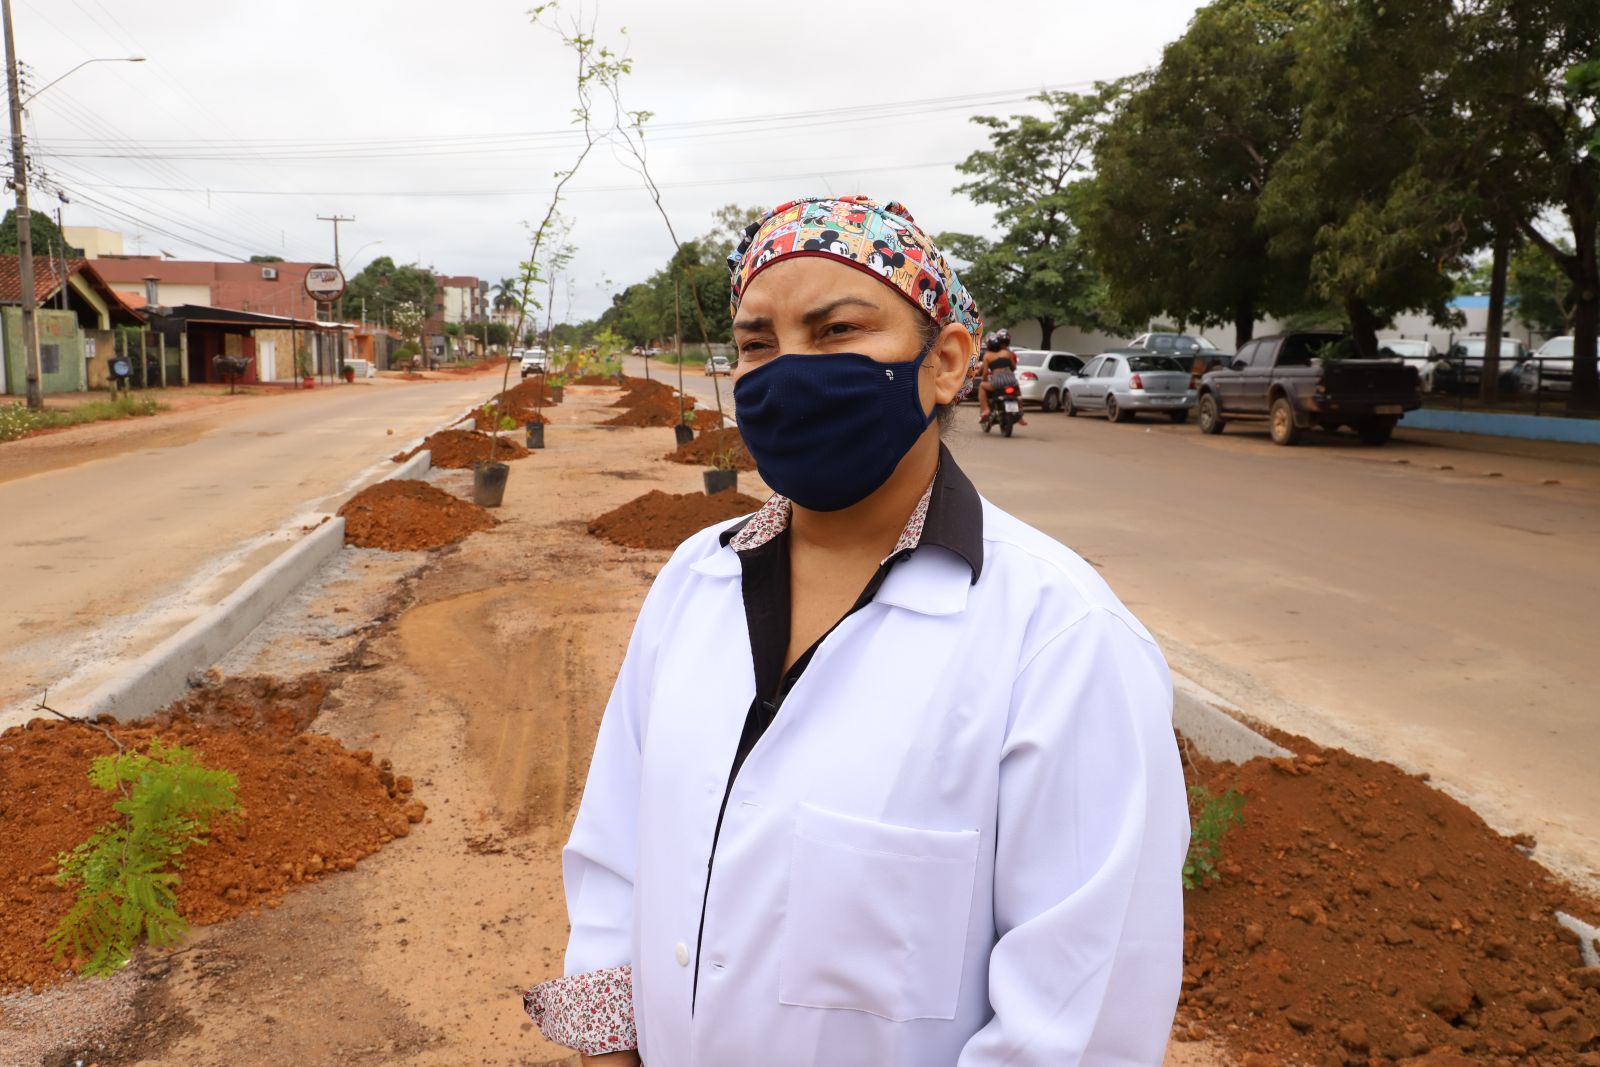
top-left (1082, 0), bottom-right (1309, 346)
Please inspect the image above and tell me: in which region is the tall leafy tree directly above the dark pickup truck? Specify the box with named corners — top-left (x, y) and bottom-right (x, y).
top-left (1261, 0), bottom-right (1482, 358)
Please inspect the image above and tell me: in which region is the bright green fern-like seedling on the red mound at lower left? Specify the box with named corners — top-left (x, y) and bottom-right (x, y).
top-left (46, 737), bottom-right (238, 977)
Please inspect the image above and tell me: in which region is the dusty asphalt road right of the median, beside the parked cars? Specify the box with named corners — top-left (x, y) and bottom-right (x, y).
top-left (643, 365), bottom-right (1600, 880)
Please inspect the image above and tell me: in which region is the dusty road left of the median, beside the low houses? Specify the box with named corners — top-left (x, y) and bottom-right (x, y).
top-left (0, 374), bottom-right (499, 728)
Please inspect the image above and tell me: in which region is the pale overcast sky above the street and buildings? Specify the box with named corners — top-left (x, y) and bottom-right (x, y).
top-left (13, 0), bottom-right (1198, 320)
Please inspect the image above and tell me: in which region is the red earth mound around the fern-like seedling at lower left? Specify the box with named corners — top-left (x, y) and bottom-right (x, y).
top-left (0, 675), bottom-right (426, 992)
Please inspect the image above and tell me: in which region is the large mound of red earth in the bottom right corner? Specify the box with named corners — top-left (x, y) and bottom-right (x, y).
top-left (1173, 737), bottom-right (1600, 1067)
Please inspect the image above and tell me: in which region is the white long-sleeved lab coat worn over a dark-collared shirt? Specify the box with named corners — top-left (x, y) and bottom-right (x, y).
top-left (563, 501), bottom-right (1189, 1067)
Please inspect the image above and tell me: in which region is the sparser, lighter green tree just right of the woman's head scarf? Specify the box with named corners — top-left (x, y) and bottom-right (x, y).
top-left (939, 82), bottom-right (1123, 347)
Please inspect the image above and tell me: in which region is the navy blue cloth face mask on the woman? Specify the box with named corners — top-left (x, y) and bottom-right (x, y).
top-left (733, 337), bottom-right (939, 512)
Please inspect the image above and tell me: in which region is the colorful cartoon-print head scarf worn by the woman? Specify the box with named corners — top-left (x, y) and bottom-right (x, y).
top-left (728, 197), bottom-right (984, 386)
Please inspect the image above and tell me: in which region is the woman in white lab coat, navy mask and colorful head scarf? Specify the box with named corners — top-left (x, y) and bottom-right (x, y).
top-left (525, 197), bottom-right (1189, 1067)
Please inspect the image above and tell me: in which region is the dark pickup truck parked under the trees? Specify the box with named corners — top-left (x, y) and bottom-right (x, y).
top-left (1197, 333), bottom-right (1422, 445)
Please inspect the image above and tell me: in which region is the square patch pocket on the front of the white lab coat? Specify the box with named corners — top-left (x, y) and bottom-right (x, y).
top-left (778, 803), bottom-right (978, 1022)
